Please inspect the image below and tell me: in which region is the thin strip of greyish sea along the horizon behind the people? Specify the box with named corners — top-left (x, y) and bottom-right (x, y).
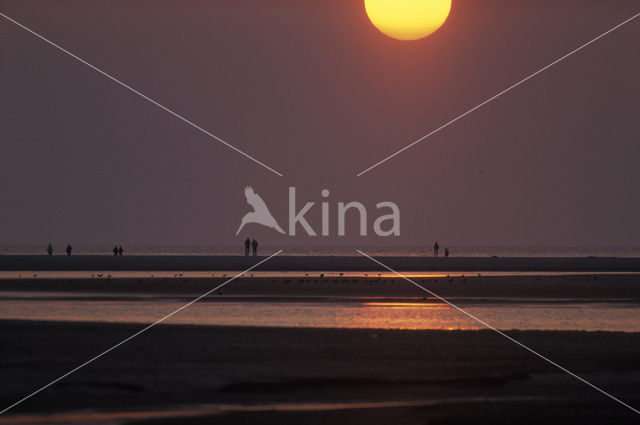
top-left (0, 243), bottom-right (640, 257)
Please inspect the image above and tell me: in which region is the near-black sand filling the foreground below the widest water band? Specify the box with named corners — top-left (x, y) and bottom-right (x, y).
top-left (0, 321), bottom-right (640, 425)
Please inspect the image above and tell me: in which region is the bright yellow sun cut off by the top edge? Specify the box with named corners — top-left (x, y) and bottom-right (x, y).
top-left (364, 0), bottom-right (451, 40)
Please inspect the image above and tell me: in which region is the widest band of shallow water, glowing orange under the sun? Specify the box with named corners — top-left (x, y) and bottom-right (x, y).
top-left (0, 292), bottom-right (640, 332)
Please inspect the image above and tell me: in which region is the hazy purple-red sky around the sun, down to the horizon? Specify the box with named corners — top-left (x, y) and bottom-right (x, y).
top-left (0, 0), bottom-right (640, 246)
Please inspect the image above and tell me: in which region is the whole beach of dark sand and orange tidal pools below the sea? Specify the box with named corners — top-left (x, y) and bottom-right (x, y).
top-left (0, 256), bottom-right (640, 424)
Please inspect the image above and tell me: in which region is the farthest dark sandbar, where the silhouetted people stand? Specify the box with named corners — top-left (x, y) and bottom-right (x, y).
top-left (0, 255), bottom-right (640, 272)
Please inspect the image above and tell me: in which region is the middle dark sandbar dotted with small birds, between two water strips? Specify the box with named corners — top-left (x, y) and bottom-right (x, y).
top-left (0, 273), bottom-right (640, 302)
